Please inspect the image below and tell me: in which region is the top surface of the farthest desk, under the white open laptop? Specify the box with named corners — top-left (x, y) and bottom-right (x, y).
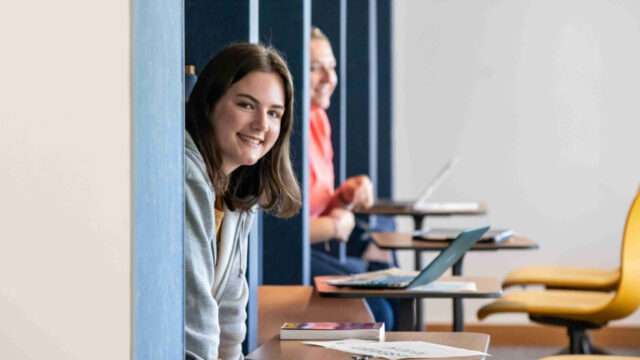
top-left (354, 201), bottom-right (487, 215)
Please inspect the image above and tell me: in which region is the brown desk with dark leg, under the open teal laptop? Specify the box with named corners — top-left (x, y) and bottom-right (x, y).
top-left (314, 276), bottom-right (502, 331)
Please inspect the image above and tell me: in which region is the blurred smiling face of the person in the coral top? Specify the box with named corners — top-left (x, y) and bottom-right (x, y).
top-left (310, 39), bottom-right (338, 109)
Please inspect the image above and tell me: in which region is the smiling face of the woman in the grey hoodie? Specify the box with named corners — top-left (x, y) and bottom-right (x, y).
top-left (209, 71), bottom-right (285, 175)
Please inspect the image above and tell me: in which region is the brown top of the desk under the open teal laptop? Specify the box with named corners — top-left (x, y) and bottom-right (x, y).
top-left (313, 276), bottom-right (502, 299)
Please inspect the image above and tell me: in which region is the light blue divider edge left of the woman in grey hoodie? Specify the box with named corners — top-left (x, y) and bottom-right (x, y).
top-left (132, 0), bottom-right (184, 360)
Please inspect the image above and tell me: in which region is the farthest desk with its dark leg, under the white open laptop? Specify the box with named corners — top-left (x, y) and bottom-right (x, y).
top-left (353, 201), bottom-right (487, 230)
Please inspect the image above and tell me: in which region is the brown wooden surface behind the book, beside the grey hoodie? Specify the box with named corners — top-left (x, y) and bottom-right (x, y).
top-left (258, 285), bottom-right (375, 345)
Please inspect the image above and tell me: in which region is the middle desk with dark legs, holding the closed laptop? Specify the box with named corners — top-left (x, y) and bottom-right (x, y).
top-left (371, 233), bottom-right (538, 331)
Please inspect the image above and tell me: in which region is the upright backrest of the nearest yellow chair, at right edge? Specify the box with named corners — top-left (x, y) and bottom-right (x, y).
top-left (593, 192), bottom-right (640, 322)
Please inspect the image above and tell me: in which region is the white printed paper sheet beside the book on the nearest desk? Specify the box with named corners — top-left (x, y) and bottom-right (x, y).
top-left (304, 339), bottom-right (491, 360)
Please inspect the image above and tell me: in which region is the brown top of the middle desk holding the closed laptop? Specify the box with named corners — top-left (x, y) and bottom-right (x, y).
top-left (371, 233), bottom-right (538, 251)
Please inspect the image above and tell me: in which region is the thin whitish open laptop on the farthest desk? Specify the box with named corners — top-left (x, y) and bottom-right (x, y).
top-left (373, 157), bottom-right (482, 212)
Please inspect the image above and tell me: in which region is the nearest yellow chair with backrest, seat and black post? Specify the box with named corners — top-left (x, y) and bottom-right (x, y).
top-left (478, 193), bottom-right (640, 354)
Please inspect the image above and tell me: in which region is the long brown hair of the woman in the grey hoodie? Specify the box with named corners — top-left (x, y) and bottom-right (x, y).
top-left (186, 43), bottom-right (302, 217)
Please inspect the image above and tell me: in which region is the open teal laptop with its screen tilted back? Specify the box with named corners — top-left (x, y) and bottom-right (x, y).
top-left (329, 226), bottom-right (489, 289)
